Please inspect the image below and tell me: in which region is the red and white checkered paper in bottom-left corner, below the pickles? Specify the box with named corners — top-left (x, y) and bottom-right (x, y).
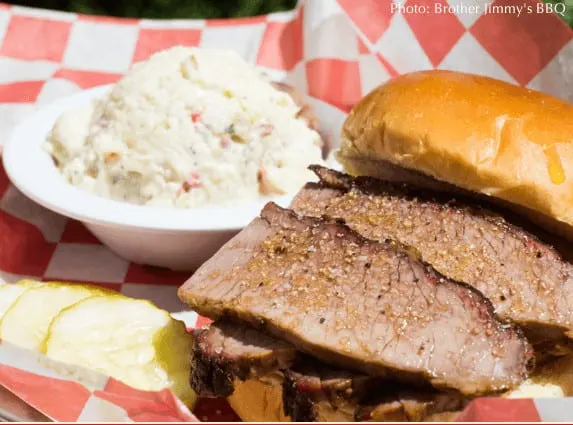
top-left (0, 342), bottom-right (197, 422)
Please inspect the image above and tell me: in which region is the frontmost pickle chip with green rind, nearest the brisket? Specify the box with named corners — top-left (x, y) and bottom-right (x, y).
top-left (43, 295), bottom-right (195, 406)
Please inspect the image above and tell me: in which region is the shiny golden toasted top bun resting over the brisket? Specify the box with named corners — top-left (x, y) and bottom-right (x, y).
top-left (337, 71), bottom-right (573, 236)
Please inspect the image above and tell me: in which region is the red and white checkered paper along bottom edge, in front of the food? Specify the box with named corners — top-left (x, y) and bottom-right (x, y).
top-left (0, 336), bottom-right (573, 422)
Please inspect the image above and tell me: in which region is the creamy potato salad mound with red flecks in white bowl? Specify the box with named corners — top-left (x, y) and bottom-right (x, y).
top-left (46, 47), bottom-right (322, 208)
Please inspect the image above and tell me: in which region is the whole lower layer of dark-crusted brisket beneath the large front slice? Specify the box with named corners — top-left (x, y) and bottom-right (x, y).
top-left (191, 322), bottom-right (469, 422)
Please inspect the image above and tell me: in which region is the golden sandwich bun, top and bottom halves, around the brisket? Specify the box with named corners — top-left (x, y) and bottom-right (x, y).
top-left (228, 71), bottom-right (573, 422)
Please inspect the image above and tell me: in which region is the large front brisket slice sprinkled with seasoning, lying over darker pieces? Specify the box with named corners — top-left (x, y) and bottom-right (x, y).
top-left (179, 203), bottom-right (532, 394)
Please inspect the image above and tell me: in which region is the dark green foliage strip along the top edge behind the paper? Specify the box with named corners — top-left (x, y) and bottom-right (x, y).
top-left (0, 0), bottom-right (573, 28)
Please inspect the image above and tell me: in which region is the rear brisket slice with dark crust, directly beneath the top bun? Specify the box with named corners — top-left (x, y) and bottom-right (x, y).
top-left (292, 166), bottom-right (573, 343)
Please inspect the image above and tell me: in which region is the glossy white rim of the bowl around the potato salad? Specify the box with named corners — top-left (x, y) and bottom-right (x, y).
top-left (1, 85), bottom-right (345, 232)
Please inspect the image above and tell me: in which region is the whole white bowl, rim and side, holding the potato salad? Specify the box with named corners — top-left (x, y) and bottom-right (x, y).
top-left (2, 86), bottom-right (346, 271)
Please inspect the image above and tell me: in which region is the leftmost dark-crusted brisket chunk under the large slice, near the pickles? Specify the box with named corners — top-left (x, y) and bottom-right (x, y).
top-left (191, 321), bottom-right (297, 397)
